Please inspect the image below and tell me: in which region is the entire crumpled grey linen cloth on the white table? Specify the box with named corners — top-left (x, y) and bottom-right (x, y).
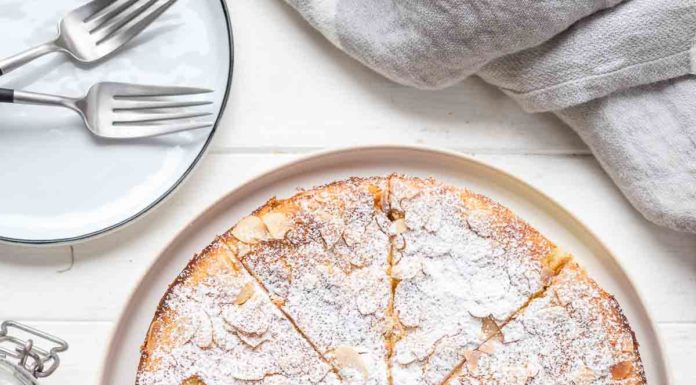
top-left (287, 0), bottom-right (696, 232)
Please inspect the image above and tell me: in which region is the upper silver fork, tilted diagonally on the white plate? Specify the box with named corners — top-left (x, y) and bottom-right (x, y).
top-left (0, 0), bottom-right (176, 76)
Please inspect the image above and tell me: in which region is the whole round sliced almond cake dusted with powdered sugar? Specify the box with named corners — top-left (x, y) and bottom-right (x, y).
top-left (136, 175), bottom-right (646, 385)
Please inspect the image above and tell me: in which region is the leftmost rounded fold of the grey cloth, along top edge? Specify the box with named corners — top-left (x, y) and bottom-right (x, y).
top-left (288, 0), bottom-right (622, 88)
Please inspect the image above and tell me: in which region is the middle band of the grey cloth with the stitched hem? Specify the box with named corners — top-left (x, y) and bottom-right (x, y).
top-left (479, 0), bottom-right (696, 112)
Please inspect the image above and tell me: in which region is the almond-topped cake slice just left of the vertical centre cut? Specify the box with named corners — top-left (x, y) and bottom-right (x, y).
top-left (223, 178), bottom-right (392, 385)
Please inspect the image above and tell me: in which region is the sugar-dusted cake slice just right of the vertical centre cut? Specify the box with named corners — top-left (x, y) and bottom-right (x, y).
top-left (388, 175), bottom-right (568, 385)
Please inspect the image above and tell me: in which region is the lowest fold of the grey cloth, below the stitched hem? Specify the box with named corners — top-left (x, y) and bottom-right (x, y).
top-left (556, 76), bottom-right (696, 233)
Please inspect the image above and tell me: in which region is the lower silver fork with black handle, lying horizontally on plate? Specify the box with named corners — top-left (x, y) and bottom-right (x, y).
top-left (0, 83), bottom-right (213, 139)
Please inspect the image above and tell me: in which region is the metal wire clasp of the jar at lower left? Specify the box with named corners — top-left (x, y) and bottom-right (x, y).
top-left (0, 321), bottom-right (68, 378)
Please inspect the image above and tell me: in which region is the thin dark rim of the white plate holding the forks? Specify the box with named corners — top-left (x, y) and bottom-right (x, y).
top-left (0, 0), bottom-right (235, 246)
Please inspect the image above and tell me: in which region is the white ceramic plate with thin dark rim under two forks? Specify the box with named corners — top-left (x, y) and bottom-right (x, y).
top-left (0, 0), bottom-right (233, 244)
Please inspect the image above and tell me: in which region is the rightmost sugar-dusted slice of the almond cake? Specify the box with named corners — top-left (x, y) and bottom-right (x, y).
top-left (448, 264), bottom-right (646, 385)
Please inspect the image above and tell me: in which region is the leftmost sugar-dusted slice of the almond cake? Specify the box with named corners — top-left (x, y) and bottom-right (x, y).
top-left (136, 242), bottom-right (340, 385)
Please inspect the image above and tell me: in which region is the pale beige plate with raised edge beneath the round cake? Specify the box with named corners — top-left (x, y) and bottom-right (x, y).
top-left (101, 146), bottom-right (670, 385)
